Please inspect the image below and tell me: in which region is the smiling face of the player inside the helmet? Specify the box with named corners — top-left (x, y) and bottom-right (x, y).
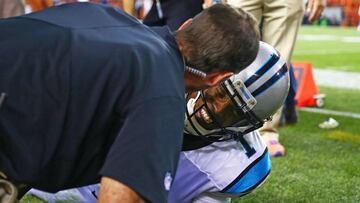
top-left (190, 85), bottom-right (241, 130)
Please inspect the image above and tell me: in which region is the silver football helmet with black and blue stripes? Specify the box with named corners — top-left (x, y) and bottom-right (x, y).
top-left (185, 42), bottom-right (290, 141)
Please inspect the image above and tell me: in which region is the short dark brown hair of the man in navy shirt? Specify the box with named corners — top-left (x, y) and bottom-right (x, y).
top-left (175, 4), bottom-right (260, 73)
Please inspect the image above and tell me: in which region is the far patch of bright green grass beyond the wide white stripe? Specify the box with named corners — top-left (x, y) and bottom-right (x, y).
top-left (293, 27), bottom-right (360, 72)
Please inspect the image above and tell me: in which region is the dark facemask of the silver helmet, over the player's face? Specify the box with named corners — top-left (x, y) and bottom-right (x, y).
top-left (185, 79), bottom-right (264, 142)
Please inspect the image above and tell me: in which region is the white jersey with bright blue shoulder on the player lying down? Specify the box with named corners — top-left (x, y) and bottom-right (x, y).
top-left (29, 131), bottom-right (271, 203)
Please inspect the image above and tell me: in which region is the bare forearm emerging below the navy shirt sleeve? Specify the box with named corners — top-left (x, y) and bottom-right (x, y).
top-left (98, 177), bottom-right (145, 203)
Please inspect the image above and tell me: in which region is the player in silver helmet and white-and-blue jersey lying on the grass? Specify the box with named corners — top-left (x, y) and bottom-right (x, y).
top-left (26, 43), bottom-right (289, 203)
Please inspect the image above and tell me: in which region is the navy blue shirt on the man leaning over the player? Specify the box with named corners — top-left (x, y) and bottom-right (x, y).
top-left (0, 3), bottom-right (185, 202)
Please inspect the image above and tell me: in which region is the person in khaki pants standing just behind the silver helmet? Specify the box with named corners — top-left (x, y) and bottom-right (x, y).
top-left (227, 0), bottom-right (326, 156)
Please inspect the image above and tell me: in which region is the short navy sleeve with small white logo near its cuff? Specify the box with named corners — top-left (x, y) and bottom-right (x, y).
top-left (100, 97), bottom-right (185, 202)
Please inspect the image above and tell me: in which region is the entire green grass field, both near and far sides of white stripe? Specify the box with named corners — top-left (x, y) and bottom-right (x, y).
top-left (21, 27), bottom-right (360, 203)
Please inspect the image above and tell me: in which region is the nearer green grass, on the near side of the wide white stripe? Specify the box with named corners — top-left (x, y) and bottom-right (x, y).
top-left (234, 88), bottom-right (360, 203)
